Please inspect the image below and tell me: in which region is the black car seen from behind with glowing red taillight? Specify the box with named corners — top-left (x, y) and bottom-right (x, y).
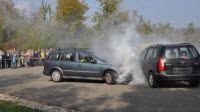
top-left (140, 43), bottom-right (200, 88)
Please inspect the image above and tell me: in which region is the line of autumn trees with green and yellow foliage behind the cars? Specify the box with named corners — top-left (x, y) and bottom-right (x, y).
top-left (0, 0), bottom-right (200, 50)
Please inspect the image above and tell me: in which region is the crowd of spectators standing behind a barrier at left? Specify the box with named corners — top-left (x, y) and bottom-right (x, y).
top-left (0, 48), bottom-right (54, 69)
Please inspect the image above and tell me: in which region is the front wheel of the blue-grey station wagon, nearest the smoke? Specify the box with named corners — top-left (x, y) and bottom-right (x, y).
top-left (104, 70), bottom-right (116, 85)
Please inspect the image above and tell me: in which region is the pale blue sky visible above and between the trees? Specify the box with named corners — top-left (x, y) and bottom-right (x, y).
top-left (13, 0), bottom-right (200, 28)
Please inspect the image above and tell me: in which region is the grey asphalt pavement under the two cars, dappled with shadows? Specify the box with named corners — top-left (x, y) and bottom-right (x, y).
top-left (0, 67), bottom-right (200, 112)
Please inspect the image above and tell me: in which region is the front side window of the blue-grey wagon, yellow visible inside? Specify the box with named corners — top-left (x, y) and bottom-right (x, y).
top-left (78, 53), bottom-right (94, 63)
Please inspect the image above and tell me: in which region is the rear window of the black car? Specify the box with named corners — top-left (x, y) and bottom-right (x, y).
top-left (163, 46), bottom-right (197, 59)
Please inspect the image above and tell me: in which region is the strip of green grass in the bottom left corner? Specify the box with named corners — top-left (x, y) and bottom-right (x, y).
top-left (0, 101), bottom-right (45, 112)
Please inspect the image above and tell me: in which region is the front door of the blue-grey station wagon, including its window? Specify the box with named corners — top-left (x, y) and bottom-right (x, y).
top-left (77, 52), bottom-right (100, 77)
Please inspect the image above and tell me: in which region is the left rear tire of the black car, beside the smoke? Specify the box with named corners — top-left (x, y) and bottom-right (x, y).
top-left (148, 72), bottom-right (158, 88)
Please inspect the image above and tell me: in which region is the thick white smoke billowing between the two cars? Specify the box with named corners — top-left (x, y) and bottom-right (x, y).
top-left (94, 24), bottom-right (146, 85)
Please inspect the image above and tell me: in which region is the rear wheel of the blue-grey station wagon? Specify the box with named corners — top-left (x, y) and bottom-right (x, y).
top-left (51, 70), bottom-right (63, 82)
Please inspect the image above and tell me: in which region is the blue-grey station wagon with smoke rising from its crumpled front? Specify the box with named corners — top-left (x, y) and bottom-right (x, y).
top-left (43, 50), bottom-right (132, 84)
